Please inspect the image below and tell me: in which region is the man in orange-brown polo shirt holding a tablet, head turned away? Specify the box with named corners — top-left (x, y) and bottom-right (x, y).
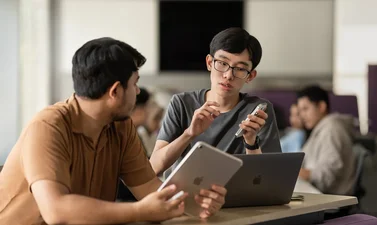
top-left (0, 38), bottom-right (226, 224)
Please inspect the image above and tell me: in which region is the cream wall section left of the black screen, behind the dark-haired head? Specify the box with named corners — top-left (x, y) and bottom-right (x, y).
top-left (53, 0), bottom-right (159, 99)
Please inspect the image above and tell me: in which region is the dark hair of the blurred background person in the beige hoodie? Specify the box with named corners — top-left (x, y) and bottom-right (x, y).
top-left (297, 85), bottom-right (330, 112)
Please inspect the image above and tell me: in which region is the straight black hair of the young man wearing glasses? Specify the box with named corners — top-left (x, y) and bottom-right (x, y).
top-left (209, 27), bottom-right (262, 70)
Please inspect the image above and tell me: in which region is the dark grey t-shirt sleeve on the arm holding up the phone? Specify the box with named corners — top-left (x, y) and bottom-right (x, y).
top-left (258, 101), bottom-right (281, 153)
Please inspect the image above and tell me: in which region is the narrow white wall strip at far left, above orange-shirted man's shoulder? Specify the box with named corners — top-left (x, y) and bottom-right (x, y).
top-left (18, 0), bottom-right (52, 129)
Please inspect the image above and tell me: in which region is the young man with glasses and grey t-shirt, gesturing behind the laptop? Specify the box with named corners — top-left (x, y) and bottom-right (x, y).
top-left (150, 28), bottom-right (281, 178)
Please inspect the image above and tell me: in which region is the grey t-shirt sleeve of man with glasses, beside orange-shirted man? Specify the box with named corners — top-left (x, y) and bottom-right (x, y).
top-left (157, 95), bottom-right (185, 143)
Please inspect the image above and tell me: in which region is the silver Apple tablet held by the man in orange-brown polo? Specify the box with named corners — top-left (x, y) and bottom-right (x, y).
top-left (158, 142), bottom-right (242, 216)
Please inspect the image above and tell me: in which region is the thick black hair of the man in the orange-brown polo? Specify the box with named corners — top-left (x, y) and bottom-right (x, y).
top-left (72, 37), bottom-right (146, 99)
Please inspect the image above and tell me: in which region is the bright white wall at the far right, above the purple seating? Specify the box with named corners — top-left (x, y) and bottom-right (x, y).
top-left (334, 0), bottom-right (377, 132)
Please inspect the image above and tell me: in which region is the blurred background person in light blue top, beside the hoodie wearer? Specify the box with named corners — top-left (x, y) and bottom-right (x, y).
top-left (280, 104), bottom-right (306, 152)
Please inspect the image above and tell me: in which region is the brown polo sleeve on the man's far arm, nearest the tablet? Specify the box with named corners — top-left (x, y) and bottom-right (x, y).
top-left (120, 119), bottom-right (156, 187)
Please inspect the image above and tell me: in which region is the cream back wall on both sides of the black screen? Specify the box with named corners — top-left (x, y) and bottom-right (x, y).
top-left (52, 0), bottom-right (333, 101)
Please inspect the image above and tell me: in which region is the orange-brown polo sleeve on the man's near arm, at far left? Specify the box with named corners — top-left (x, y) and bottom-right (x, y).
top-left (21, 121), bottom-right (71, 190)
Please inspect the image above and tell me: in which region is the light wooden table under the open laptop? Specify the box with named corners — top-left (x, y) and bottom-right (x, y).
top-left (134, 193), bottom-right (358, 225)
